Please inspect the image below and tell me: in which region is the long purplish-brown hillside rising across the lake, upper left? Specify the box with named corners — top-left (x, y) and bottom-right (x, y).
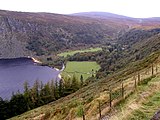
top-left (0, 10), bottom-right (128, 57)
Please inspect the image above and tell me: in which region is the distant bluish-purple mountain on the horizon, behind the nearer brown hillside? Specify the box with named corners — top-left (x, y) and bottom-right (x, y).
top-left (73, 12), bottom-right (160, 29)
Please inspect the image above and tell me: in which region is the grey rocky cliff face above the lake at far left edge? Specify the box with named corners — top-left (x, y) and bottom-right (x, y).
top-left (0, 17), bottom-right (29, 58)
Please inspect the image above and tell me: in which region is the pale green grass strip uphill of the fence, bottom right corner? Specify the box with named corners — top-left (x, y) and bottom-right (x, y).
top-left (105, 74), bottom-right (160, 120)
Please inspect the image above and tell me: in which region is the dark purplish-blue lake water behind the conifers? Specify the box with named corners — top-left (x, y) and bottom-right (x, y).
top-left (0, 58), bottom-right (59, 99)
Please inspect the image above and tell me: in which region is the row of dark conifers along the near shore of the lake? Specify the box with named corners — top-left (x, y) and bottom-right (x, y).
top-left (0, 75), bottom-right (83, 120)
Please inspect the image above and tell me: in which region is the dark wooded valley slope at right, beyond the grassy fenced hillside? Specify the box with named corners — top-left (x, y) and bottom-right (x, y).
top-left (97, 28), bottom-right (160, 76)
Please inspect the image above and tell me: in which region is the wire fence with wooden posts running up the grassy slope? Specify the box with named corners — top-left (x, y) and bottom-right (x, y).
top-left (82, 58), bottom-right (160, 120)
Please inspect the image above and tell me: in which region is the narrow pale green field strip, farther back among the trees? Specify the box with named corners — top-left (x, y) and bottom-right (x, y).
top-left (58, 47), bottom-right (102, 57)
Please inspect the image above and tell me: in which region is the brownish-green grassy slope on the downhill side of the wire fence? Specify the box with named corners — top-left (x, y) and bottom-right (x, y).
top-left (12, 50), bottom-right (159, 120)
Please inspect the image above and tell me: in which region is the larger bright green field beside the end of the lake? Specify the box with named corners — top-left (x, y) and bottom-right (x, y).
top-left (62, 61), bottom-right (100, 80)
